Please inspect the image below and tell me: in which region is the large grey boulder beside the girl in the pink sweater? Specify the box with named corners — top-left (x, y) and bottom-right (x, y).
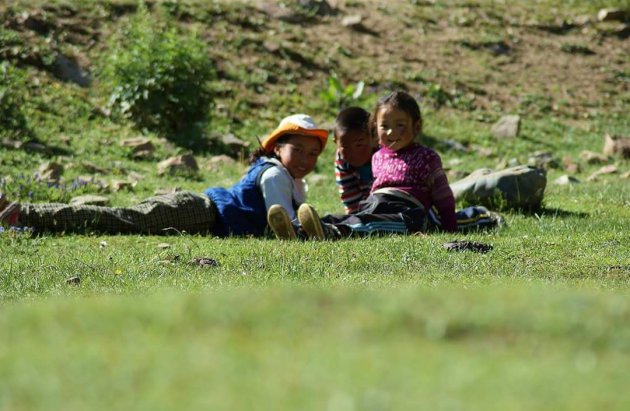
top-left (451, 166), bottom-right (547, 210)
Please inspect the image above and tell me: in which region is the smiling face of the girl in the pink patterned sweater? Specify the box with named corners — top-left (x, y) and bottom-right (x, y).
top-left (376, 106), bottom-right (420, 151)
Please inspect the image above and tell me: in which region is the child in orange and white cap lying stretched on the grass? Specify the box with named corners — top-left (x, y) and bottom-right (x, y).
top-left (0, 114), bottom-right (328, 237)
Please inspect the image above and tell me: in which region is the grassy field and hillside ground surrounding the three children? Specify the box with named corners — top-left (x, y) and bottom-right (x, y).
top-left (0, 0), bottom-right (630, 411)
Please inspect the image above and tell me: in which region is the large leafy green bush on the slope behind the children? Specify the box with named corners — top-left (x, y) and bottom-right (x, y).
top-left (104, 7), bottom-right (214, 136)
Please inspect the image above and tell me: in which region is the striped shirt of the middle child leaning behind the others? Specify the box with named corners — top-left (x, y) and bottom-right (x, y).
top-left (335, 150), bottom-right (374, 214)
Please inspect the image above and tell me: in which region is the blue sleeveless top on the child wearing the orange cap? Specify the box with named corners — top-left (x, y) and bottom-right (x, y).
top-left (205, 157), bottom-right (276, 237)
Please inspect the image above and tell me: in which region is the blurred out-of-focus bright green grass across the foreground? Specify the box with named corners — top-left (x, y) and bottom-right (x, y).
top-left (0, 281), bottom-right (630, 410)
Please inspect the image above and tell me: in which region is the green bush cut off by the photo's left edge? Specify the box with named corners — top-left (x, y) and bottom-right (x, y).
top-left (0, 61), bottom-right (29, 136)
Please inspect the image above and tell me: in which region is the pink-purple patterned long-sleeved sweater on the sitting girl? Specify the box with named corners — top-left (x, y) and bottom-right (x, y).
top-left (372, 143), bottom-right (457, 231)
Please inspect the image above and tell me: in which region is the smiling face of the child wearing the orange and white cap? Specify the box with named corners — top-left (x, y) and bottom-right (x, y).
top-left (274, 135), bottom-right (322, 178)
